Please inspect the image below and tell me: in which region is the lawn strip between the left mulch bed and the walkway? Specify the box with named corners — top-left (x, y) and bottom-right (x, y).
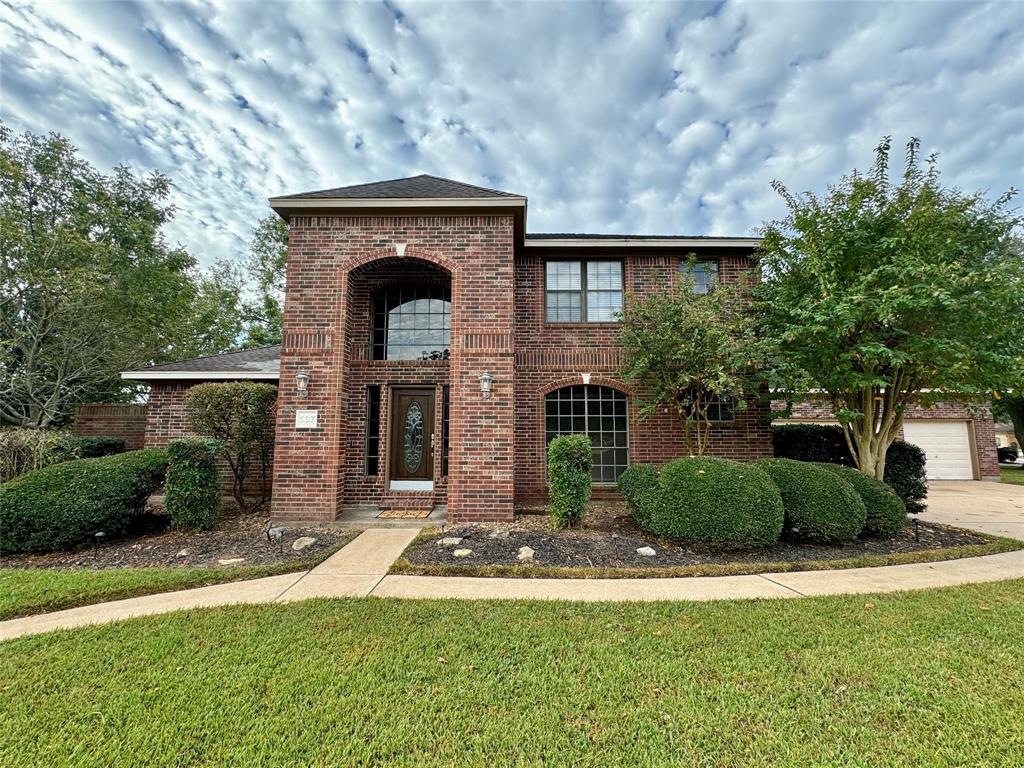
top-left (0, 547), bottom-right (350, 620)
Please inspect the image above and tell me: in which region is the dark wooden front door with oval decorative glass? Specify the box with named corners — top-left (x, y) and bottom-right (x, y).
top-left (388, 387), bottom-right (434, 480)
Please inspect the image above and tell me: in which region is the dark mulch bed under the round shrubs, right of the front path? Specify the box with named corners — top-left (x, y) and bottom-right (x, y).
top-left (404, 503), bottom-right (1007, 568)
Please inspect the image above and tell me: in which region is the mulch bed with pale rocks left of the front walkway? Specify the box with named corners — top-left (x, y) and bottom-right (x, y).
top-left (0, 511), bottom-right (359, 568)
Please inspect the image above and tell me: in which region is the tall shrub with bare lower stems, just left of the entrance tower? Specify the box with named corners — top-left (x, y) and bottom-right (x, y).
top-left (185, 381), bottom-right (278, 511)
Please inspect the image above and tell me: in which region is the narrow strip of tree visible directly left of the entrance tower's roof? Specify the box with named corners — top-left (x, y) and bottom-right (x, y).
top-left (245, 214), bottom-right (288, 347)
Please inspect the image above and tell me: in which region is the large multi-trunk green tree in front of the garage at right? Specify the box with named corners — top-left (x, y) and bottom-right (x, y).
top-left (755, 137), bottom-right (1024, 478)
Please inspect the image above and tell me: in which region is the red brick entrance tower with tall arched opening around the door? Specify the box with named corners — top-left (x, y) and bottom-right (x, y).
top-left (273, 215), bottom-right (514, 521)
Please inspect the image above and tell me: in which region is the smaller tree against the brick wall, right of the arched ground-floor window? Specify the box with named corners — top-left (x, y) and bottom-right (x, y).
top-left (618, 264), bottom-right (763, 456)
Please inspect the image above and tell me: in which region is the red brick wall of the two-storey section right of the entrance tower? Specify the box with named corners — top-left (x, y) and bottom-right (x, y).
top-left (515, 250), bottom-right (772, 502)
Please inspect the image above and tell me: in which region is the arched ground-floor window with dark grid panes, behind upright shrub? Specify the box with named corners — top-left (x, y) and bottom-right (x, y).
top-left (544, 384), bottom-right (630, 482)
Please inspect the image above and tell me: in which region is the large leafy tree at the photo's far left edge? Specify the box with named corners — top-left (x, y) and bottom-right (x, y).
top-left (0, 125), bottom-right (242, 427)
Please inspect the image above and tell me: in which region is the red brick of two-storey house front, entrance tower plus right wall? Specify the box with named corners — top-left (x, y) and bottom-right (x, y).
top-left (273, 215), bottom-right (771, 521)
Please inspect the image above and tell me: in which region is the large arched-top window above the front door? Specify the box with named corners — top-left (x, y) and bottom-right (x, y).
top-left (370, 285), bottom-right (452, 360)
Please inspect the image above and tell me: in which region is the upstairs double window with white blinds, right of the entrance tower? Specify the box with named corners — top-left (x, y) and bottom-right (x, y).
top-left (544, 261), bottom-right (623, 323)
